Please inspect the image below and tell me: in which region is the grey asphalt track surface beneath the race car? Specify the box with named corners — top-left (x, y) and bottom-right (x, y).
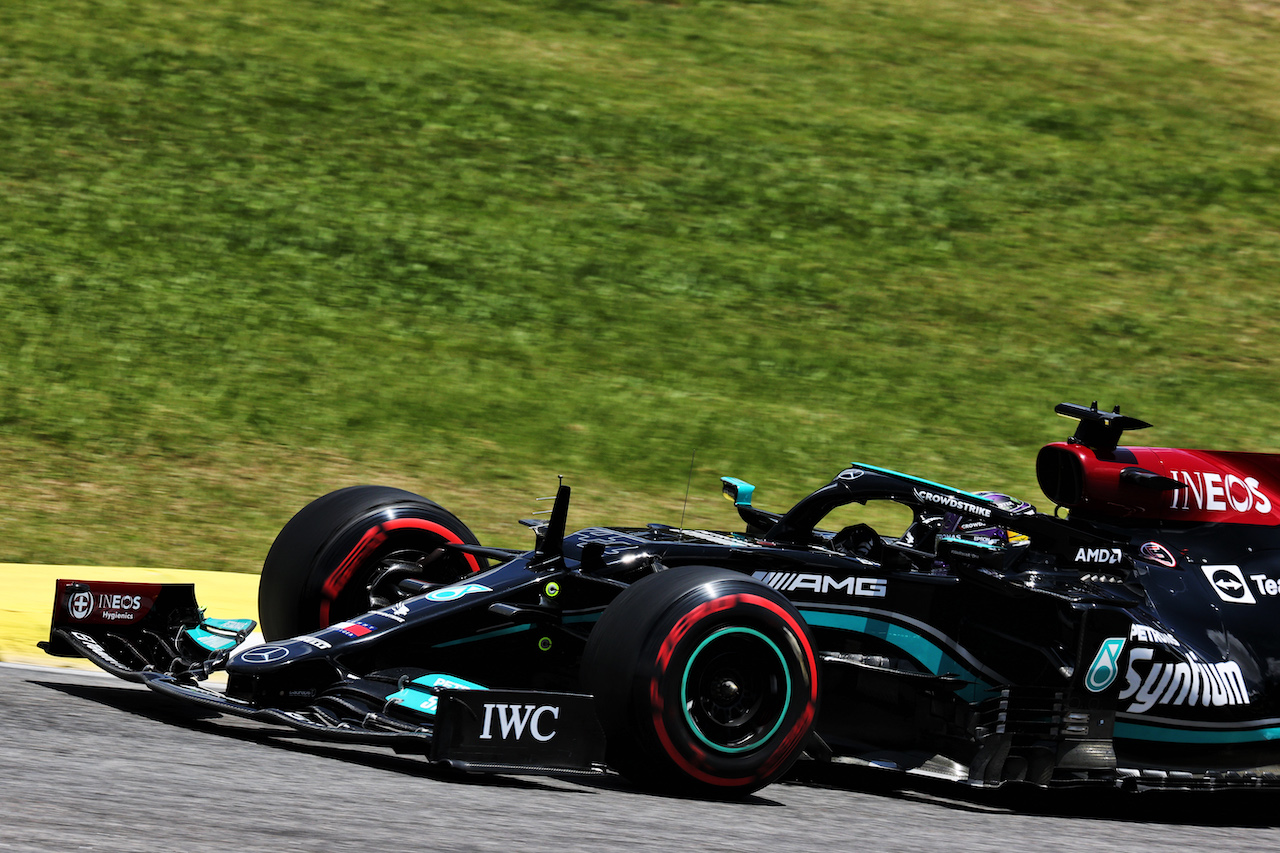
top-left (0, 665), bottom-right (1280, 853)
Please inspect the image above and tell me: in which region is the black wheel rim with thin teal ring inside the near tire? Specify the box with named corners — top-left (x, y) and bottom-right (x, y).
top-left (680, 626), bottom-right (791, 754)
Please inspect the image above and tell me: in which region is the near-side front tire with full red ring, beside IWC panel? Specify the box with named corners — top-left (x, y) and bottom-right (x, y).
top-left (581, 566), bottom-right (819, 798)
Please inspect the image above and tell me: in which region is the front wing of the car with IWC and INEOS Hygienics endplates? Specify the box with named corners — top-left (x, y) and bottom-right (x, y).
top-left (40, 580), bottom-right (604, 774)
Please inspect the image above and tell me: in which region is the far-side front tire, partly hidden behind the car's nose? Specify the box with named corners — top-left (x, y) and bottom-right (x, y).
top-left (257, 485), bottom-right (488, 642)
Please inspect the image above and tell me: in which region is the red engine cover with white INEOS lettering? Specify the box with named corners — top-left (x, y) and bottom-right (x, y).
top-left (1036, 442), bottom-right (1280, 525)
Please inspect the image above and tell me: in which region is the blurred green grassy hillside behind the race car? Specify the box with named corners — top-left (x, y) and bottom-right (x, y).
top-left (0, 0), bottom-right (1280, 569)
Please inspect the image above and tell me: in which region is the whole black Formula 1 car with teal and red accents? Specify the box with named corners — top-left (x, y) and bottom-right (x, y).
top-left (35, 403), bottom-right (1280, 795)
